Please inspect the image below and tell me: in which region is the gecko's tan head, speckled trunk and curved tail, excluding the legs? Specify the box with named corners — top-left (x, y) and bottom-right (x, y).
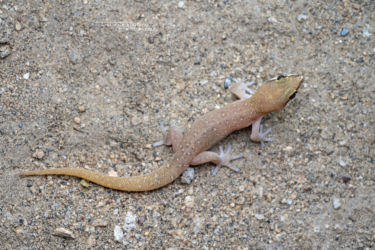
top-left (20, 76), bottom-right (303, 191)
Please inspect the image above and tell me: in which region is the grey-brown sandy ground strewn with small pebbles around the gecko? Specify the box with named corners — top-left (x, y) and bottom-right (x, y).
top-left (0, 0), bottom-right (375, 249)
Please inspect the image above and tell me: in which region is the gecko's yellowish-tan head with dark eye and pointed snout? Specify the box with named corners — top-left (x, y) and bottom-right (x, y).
top-left (252, 75), bottom-right (303, 114)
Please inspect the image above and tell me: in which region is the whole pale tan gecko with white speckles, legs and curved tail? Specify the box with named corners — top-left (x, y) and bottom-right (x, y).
top-left (19, 75), bottom-right (303, 192)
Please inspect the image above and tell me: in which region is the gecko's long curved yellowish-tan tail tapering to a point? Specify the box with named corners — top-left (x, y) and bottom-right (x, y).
top-left (19, 166), bottom-right (183, 192)
